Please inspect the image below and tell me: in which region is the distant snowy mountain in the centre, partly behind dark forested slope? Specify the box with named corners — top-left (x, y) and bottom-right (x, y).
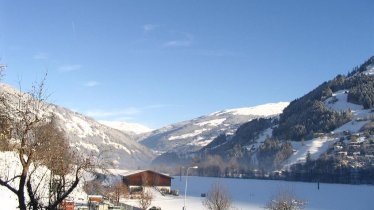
top-left (140, 102), bottom-right (289, 154)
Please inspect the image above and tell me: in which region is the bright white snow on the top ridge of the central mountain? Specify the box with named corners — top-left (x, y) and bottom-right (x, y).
top-left (221, 102), bottom-right (289, 116)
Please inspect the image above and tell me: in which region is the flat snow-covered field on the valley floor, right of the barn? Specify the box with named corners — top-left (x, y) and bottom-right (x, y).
top-left (121, 177), bottom-right (374, 210)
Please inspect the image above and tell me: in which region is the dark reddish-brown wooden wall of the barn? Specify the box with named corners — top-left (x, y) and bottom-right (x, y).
top-left (123, 171), bottom-right (171, 186)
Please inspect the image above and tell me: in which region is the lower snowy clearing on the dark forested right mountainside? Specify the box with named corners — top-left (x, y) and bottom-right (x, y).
top-left (283, 137), bottom-right (338, 169)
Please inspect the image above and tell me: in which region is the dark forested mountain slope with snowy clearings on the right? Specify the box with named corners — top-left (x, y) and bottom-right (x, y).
top-left (196, 57), bottom-right (374, 174)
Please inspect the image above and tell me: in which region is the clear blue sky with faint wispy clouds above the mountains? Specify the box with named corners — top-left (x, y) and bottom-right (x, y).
top-left (0, 0), bottom-right (374, 128)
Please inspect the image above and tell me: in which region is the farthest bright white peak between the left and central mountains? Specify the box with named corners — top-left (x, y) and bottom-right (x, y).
top-left (99, 120), bottom-right (153, 135)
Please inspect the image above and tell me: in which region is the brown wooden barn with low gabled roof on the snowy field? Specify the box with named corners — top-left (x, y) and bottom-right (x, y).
top-left (120, 170), bottom-right (172, 191)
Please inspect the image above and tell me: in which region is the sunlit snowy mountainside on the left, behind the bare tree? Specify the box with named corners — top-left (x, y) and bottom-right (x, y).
top-left (0, 84), bottom-right (153, 168)
